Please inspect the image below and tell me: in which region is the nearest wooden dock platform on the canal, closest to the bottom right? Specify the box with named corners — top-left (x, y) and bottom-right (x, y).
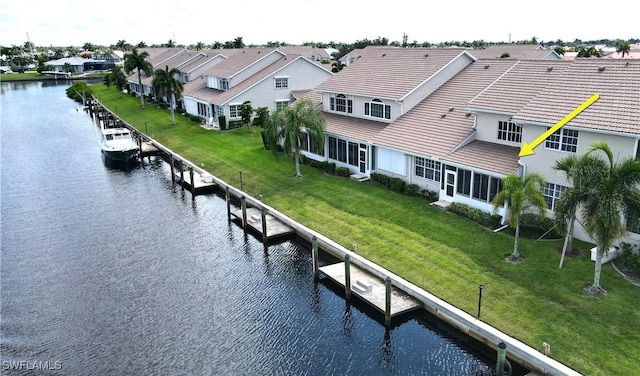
top-left (319, 262), bottom-right (422, 317)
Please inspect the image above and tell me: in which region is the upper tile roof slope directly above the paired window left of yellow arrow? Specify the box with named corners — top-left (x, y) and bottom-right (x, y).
top-left (468, 60), bottom-right (571, 114)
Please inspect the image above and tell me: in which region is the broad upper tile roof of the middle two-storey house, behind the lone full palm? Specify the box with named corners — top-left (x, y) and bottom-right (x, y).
top-left (317, 46), bottom-right (476, 100)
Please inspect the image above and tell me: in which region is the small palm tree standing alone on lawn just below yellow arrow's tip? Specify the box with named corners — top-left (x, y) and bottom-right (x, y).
top-left (493, 173), bottom-right (547, 261)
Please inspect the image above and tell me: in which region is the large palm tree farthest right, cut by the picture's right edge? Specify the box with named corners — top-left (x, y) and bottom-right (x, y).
top-left (579, 141), bottom-right (640, 295)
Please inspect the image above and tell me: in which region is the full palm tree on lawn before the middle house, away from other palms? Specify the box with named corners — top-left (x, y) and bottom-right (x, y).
top-left (264, 99), bottom-right (325, 177)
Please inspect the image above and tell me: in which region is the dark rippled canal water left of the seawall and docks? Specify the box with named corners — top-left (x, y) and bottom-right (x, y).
top-left (0, 82), bottom-right (524, 375)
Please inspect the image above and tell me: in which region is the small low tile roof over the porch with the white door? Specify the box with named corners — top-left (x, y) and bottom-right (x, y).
top-left (442, 141), bottom-right (520, 175)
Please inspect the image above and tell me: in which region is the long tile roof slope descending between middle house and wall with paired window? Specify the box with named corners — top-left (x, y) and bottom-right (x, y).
top-left (373, 60), bottom-right (516, 158)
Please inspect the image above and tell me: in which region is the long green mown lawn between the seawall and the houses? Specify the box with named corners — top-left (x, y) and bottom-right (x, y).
top-left (92, 85), bottom-right (640, 375)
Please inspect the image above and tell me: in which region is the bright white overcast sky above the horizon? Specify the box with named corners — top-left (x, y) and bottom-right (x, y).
top-left (0, 0), bottom-right (640, 47)
